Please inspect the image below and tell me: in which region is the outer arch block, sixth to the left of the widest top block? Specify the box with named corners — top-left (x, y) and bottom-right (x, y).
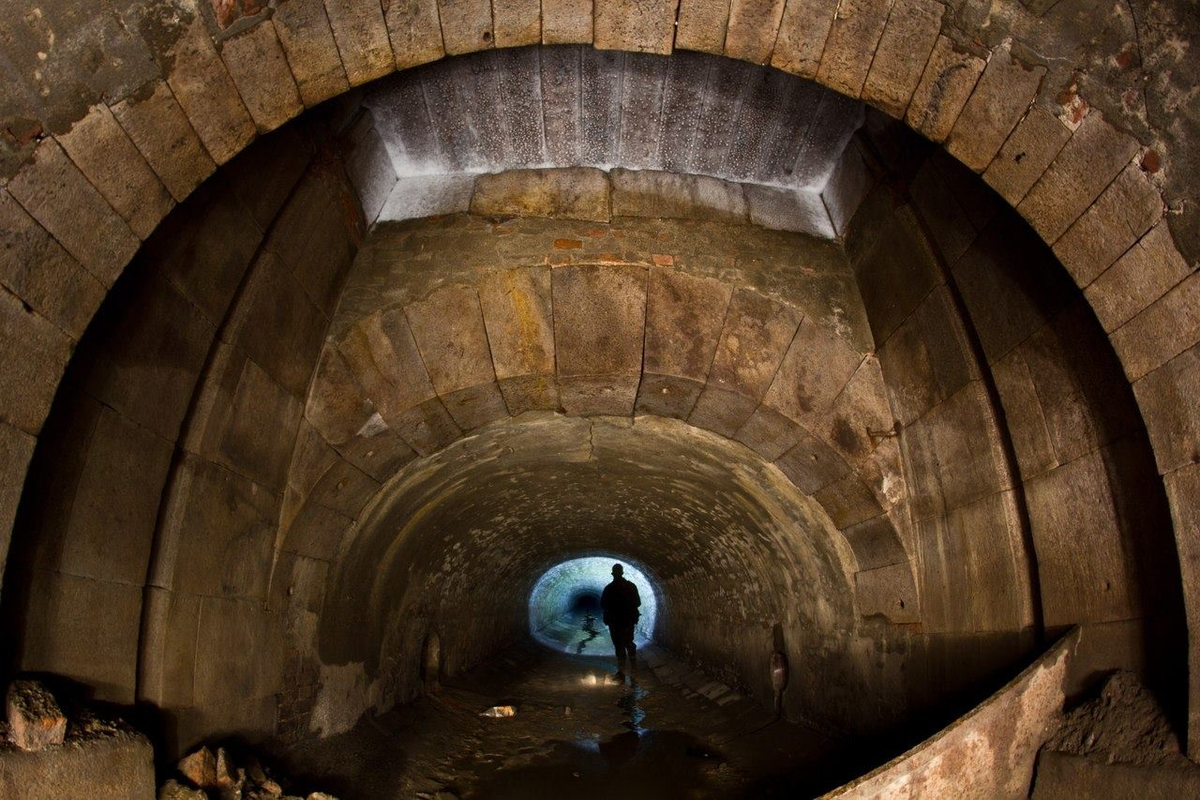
top-left (271, 0), bottom-right (355, 108)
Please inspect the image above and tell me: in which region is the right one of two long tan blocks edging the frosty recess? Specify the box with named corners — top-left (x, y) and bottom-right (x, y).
top-left (611, 169), bottom-right (749, 222)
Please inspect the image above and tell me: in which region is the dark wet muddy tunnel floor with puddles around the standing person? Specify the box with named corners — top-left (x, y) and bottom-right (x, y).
top-left (281, 625), bottom-right (856, 800)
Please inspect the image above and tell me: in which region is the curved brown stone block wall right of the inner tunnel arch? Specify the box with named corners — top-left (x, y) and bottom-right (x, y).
top-left (848, 118), bottom-right (1186, 722)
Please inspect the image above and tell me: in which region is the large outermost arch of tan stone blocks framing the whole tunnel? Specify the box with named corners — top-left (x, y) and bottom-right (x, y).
top-left (0, 0), bottom-right (1200, 752)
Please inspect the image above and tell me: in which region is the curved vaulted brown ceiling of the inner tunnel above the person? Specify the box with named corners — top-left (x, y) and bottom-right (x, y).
top-left (319, 411), bottom-right (854, 675)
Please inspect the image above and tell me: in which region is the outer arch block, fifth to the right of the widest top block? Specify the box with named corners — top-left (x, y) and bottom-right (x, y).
top-left (862, 0), bottom-right (946, 119)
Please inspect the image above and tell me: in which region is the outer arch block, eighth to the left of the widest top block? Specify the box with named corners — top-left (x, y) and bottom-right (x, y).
top-left (164, 10), bottom-right (258, 164)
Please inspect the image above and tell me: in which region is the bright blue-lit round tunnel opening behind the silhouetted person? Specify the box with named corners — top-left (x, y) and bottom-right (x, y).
top-left (529, 555), bottom-right (659, 656)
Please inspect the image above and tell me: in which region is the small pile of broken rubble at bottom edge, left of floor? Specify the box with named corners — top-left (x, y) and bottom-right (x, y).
top-left (158, 747), bottom-right (337, 800)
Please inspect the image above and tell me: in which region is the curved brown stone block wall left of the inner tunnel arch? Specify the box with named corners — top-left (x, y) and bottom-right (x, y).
top-left (4, 124), bottom-right (361, 747)
